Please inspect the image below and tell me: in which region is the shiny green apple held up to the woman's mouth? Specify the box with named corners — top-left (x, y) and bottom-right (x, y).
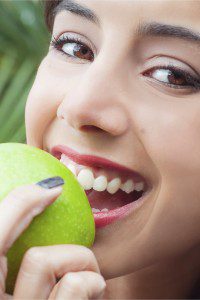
top-left (0, 143), bottom-right (95, 294)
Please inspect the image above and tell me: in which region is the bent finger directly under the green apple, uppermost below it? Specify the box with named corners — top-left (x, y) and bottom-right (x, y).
top-left (14, 245), bottom-right (100, 299)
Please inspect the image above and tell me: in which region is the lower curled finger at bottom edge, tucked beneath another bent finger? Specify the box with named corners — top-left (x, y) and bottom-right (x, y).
top-left (54, 271), bottom-right (106, 300)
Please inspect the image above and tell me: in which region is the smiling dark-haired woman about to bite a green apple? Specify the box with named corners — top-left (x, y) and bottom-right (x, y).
top-left (0, 0), bottom-right (200, 299)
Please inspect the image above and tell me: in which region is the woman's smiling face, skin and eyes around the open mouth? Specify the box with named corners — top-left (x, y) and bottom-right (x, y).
top-left (25, 0), bottom-right (200, 278)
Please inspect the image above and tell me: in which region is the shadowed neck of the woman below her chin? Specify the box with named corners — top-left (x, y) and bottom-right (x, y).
top-left (104, 247), bottom-right (200, 299)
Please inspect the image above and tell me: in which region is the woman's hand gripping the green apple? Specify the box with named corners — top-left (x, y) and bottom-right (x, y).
top-left (0, 185), bottom-right (106, 300)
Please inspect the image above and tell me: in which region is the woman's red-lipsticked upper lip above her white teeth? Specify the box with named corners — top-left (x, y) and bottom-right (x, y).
top-left (50, 145), bottom-right (146, 182)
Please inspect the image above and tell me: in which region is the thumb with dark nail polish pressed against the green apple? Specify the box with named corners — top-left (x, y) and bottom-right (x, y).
top-left (0, 184), bottom-right (62, 255)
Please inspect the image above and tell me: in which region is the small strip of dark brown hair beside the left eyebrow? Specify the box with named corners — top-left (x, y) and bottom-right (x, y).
top-left (44, 0), bottom-right (62, 32)
